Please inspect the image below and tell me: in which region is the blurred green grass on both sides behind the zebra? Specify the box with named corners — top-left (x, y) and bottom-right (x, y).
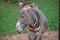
top-left (0, 0), bottom-right (59, 34)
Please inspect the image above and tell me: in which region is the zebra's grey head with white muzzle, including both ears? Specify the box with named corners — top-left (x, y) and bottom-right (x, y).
top-left (16, 3), bottom-right (36, 33)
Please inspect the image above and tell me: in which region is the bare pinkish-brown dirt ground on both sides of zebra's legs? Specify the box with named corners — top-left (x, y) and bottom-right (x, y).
top-left (1, 31), bottom-right (58, 40)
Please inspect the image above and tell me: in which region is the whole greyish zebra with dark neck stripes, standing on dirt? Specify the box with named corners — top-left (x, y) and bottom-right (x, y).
top-left (16, 2), bottom-right (48, 40)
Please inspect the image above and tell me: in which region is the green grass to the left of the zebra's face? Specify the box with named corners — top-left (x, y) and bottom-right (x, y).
top-left (0, 3), bottom-right (19, 34)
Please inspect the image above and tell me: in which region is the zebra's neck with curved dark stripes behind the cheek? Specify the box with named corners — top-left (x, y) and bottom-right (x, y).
top-left (29, 10), bottom-right (40, 32)
